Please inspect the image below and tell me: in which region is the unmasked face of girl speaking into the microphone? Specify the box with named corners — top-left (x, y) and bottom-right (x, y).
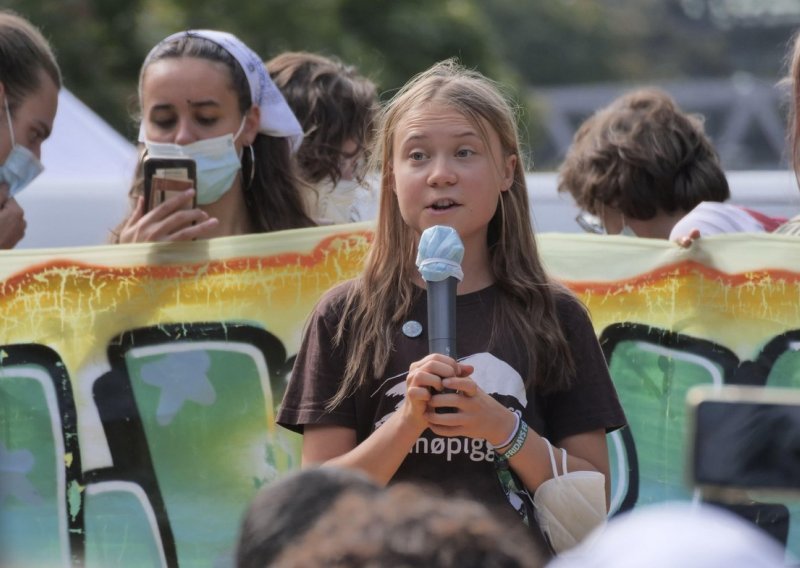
top-left (392, 103), bottom-right (517, 253)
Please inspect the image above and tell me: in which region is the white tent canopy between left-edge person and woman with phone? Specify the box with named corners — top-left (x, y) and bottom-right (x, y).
top-left (17, 89), bottom-right (136, 248)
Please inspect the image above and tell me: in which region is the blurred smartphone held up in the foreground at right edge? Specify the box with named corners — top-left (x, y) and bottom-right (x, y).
top-left (686, 385), bottom-right (800, 502)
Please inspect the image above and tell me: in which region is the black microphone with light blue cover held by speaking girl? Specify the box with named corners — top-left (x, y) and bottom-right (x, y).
top-left (417, 225), bottom-right (464, 412)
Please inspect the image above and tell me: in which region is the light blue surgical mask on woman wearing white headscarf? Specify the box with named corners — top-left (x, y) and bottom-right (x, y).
top-left (144, 119), bottom-right (244, 205)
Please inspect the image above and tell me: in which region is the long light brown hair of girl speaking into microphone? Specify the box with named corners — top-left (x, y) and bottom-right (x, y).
top-left (329, 59), bottom-right (574, 407)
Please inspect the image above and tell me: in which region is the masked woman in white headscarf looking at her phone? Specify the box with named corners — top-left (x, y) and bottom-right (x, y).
top-left (114, 30), bottom-right (314, 243)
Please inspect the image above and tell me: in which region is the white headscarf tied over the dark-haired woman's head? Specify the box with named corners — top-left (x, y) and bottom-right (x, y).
top-left (140, 30), bottom-right (303, 152)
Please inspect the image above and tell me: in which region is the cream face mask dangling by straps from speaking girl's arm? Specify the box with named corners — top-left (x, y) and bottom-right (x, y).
top-left (533, 438), bottom-right (607, 554)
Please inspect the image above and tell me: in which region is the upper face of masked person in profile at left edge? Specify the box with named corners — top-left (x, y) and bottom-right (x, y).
top-left (0, 71), bottom-right (58, 164)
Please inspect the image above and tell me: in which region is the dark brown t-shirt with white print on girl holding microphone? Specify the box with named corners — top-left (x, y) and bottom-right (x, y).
top-left (277, 283), bottom-right (625, 508)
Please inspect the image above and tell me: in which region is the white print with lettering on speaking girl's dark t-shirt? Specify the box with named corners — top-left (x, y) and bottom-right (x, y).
top-left (375, 353), bottom-right (528, 461)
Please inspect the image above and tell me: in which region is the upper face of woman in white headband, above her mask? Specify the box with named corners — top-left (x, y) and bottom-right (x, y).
top-left (141, 57), bottom-right (258, 150)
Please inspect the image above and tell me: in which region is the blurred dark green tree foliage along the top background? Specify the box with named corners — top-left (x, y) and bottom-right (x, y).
top-left (4, 0), bottom-right (797, 154)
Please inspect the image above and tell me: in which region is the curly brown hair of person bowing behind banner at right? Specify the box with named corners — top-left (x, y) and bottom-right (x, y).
top-left (558, 88), bottom-right (730, 220)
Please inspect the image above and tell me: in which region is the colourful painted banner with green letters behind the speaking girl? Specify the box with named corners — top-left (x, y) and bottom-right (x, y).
top-left (0, 224), bottom-right (800, 566)
